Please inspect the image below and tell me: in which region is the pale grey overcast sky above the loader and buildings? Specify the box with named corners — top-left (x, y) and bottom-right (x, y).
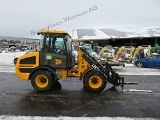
top-left (0, 0), bottom-right (160, 38)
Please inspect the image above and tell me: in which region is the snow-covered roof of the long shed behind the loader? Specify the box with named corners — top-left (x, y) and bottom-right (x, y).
top-left (72, 27), bottom-right (160, 41)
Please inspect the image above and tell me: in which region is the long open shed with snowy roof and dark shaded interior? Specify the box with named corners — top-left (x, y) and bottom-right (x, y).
top-left (72, 27), bottom-right (160, 47)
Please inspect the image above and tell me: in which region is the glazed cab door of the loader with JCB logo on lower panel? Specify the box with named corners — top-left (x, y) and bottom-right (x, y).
top-left (42, 34), bottom-right (66, 68)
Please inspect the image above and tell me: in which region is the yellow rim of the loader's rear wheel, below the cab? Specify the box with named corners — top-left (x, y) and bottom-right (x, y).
top-left (35, 75), bottom-right (48, 88)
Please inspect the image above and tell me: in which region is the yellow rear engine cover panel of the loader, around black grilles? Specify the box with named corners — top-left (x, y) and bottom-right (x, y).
top-left (15, 52), bottom-right (39, 80)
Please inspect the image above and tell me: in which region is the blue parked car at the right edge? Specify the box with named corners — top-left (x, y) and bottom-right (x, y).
top-left (134, 54), bottom-right (160, 67)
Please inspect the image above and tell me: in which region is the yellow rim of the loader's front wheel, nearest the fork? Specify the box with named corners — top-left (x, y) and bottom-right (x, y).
top-left (89, 75), bottom-right (102, 89)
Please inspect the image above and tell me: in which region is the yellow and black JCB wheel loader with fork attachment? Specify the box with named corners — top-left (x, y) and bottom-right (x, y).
top-left (15, 30), bottom-right (124, 93)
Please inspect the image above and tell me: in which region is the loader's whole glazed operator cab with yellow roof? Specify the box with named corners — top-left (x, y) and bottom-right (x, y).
top-left (38, 30), bottom-right (75, 69)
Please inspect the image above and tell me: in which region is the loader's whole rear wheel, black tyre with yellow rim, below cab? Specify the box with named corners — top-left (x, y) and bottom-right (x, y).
top-left (31, 70), bottom-right (55, 91)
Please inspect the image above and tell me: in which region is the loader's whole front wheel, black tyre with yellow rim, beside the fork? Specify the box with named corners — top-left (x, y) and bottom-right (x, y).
top-left (83, 70), bottom-right (107, 93)
